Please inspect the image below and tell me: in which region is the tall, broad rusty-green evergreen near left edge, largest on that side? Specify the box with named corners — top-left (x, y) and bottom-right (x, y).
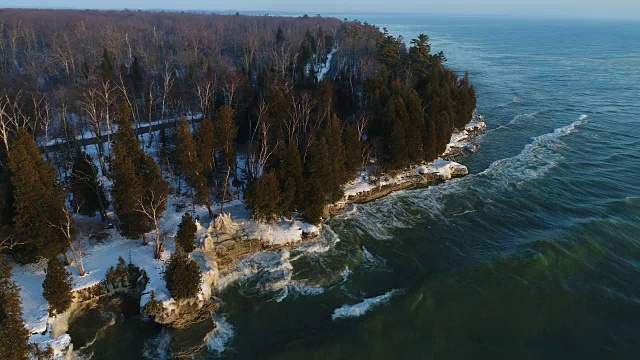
top-left (9, 129), bottom-right (67, 261)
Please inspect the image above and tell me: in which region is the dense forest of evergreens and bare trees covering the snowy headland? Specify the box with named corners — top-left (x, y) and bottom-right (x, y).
top-left (0, 9), bottom-right (476, 358)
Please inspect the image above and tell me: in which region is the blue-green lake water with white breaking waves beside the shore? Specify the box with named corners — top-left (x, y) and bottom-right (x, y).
top-left (76, 16), bottom-right (640, 359)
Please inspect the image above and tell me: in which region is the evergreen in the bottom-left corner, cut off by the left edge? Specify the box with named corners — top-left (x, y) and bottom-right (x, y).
top-left (0, 255), bottom-right (30, 360)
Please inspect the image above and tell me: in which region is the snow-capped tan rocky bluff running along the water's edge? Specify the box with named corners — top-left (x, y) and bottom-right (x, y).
top-left (23, 117), bottom-right (486, 358)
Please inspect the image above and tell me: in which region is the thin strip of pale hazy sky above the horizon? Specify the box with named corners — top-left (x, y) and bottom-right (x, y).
top-left (0, 0), bottom-right (640, 19)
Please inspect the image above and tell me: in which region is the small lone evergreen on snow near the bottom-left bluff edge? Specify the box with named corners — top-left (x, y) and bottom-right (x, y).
top-left (42, 258), bottom-right (71, 315)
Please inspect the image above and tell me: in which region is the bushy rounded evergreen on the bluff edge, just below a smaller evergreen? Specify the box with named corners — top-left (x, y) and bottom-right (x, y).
top-left (163, 250), bottom-right (202, 300)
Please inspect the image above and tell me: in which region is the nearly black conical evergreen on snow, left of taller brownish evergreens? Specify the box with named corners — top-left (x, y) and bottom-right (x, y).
top-left (71, 149), bottom-right (107, 220)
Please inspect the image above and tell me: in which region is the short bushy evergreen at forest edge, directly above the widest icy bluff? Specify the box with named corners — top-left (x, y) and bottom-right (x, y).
top-left (245, 171), bottom-right (280, 221)
